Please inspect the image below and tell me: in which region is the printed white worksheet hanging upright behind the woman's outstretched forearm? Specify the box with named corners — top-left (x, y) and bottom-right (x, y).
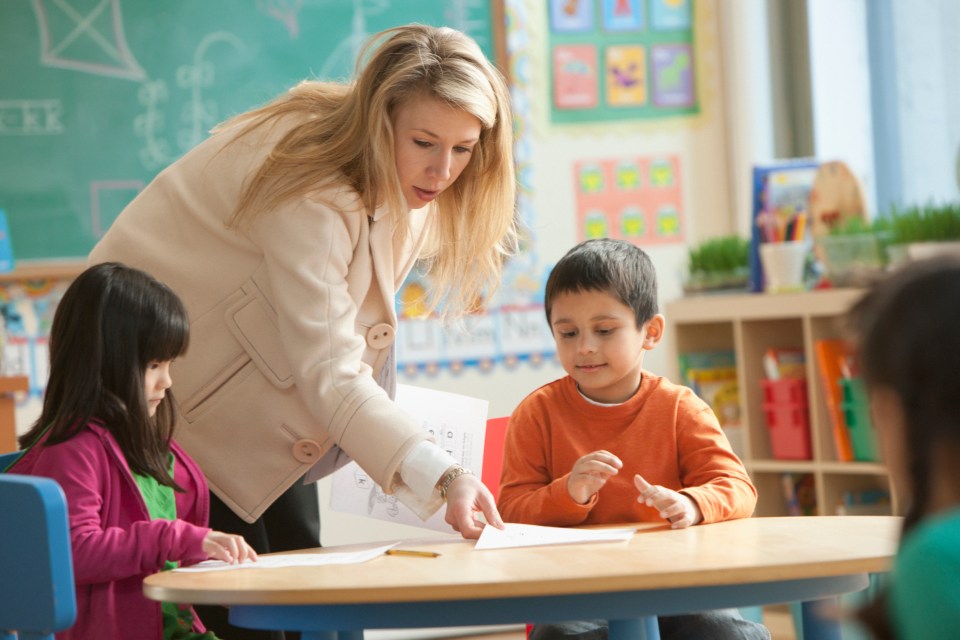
top-left (330, 384), bottom-right (489, 533)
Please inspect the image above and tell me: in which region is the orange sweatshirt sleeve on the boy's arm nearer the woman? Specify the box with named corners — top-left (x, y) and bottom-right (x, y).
top-left (497, 397), bottom-right (597, 527)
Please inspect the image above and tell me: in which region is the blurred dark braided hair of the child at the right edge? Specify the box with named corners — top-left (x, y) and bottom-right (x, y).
top-left (847, 256), bottom-right (960, 639)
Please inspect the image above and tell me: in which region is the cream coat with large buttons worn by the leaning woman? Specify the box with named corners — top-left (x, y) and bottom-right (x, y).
top-left (89, 116), bottom-right (429, 522)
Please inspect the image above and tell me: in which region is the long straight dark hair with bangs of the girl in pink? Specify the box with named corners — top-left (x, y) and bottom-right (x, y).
top-left (19, 262), bottom-right (190, 489)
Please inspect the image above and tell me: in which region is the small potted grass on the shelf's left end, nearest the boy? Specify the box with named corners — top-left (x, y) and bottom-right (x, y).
top-left (683, 235), bottom-right (750, 294)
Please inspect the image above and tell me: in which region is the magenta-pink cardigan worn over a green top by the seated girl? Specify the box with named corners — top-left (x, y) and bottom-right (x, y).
top-left (10, 423), bottom-right (210, 640)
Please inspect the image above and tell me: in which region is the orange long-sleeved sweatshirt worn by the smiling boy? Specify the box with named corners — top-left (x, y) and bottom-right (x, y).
top-left (497, 371), bottom-right (757, 526)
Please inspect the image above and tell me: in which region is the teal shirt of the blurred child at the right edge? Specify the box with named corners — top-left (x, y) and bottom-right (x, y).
top-left (890, 509), bottom-right (960, 640)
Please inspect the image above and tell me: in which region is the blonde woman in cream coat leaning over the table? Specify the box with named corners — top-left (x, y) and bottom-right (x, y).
top-left (89, 25), bottom-right (516, 637)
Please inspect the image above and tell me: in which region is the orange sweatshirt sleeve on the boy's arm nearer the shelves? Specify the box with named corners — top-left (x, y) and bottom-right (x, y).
top-left (677, 391), bottom-right (757, 524)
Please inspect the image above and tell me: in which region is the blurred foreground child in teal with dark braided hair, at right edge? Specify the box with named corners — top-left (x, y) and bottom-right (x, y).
top-left (848, 257), bottom-right (960, 639)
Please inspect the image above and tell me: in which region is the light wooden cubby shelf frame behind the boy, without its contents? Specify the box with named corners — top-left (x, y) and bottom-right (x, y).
top-left (664, 289), bottom-right (903, 516)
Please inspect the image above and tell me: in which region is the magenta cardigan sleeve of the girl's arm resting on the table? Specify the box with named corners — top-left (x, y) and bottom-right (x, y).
top-left (33, 443), bottom-right (209, 585)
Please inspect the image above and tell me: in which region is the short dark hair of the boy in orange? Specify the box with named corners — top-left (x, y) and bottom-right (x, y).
top-left (543, 238), bottom-right (658, 327)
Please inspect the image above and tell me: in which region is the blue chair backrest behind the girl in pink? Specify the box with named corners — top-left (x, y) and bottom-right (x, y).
top-left (0, 468), bottom-right (77, 640)
